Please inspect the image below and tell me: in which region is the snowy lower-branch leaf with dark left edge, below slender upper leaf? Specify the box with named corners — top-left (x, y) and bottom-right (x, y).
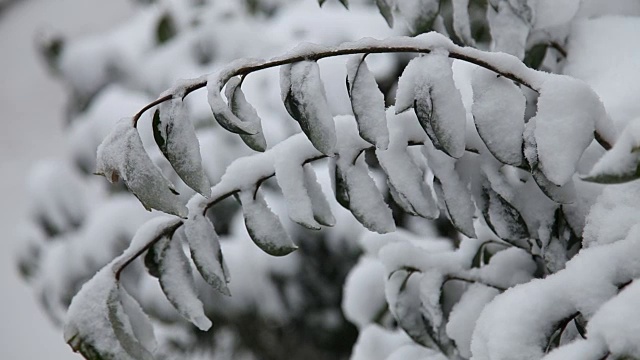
top-left (340, 158), bottom-right (396, 234)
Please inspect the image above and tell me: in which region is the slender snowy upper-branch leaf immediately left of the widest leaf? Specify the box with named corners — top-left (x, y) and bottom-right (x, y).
top-left (347, 56), bottom-right (389, 149)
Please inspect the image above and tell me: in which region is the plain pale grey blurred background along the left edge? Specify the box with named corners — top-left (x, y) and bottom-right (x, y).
top-left (0, 0), bottom-right (131, 360)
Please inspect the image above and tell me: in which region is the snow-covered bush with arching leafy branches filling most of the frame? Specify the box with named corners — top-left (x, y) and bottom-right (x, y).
top-left (20, 0), bottom-right (640, 360)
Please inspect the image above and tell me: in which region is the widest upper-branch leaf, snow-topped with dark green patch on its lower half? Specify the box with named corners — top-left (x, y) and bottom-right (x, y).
top-left (396, 53), bottom-right (467, 159)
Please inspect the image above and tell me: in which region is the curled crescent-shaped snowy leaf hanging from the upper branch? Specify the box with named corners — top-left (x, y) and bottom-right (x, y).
top-left (207, 74), bottom-right (260, 135)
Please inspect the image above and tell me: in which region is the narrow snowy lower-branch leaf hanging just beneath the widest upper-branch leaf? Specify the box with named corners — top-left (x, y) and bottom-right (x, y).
top-left (423, 145), bottom-right (476, 238)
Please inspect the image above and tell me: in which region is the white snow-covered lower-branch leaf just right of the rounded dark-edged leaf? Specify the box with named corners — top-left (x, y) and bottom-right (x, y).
top-left (275, 157), bottom-right (320, 230)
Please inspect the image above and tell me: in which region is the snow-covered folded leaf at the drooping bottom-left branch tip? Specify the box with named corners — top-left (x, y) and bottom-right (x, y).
top-left (64, 266), bottom-right (155, 360)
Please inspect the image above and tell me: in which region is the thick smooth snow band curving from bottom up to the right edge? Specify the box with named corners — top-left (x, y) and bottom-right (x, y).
top-left (471, 227), bottom-right (640, 360)
